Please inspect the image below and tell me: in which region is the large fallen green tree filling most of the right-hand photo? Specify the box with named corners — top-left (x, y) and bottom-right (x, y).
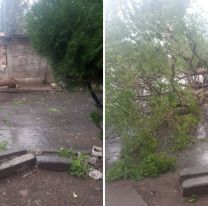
top-left (106, 0), bottom-right (208, 180)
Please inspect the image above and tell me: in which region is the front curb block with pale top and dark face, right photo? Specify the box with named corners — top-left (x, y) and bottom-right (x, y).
top-left (181, 176), bottom-right (208, 197)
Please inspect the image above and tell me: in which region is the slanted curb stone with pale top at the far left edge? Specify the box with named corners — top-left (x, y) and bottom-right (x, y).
top-left (0, 154), bottom-right (35, 178)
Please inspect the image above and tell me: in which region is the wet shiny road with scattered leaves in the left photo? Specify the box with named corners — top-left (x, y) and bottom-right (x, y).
top-left (0, 92), bottom-right (102, 150)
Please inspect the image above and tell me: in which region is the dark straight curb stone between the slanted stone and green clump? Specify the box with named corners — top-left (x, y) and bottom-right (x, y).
top-left (37, 156), bottom-right (71, 171)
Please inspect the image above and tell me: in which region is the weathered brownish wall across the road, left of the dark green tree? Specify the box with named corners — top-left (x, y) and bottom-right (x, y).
top-left (0, 37), bottom-right (52, 83)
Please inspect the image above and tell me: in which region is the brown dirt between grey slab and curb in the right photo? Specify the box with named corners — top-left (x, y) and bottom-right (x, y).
top-left (136, 173), bottom-right (208, 206)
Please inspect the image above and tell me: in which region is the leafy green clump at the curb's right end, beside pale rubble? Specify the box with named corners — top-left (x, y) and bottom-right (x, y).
top-left (70, 153), bottom-right (90, 177)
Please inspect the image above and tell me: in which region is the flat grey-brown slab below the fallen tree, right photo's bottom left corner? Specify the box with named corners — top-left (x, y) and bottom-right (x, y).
top-left (106, 181), bottom-right (147, 206)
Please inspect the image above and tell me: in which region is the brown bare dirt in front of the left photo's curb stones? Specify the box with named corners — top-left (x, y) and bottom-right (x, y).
top-left (0, 169), bottom-right (102, 206)
